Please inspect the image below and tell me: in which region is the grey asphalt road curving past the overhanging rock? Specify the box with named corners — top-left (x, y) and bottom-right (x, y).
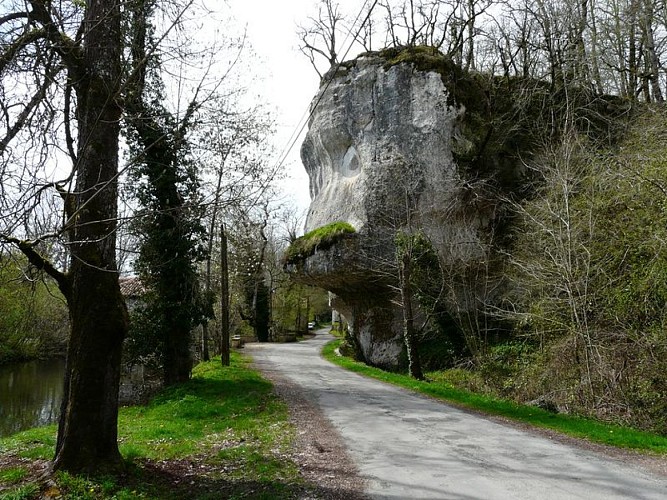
top-left (249, 330), bottom-right (667, 500)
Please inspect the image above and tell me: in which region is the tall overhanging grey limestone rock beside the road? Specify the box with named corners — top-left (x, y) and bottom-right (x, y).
top-left (292, 50), bottom-right (494, 368)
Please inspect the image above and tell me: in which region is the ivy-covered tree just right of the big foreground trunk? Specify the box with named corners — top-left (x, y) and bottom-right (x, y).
top-left (126, 0), bottom-right (211, 385)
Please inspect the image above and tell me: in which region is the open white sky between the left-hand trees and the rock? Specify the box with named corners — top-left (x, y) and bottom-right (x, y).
top-left (229, 0), bottom-right (364, 215)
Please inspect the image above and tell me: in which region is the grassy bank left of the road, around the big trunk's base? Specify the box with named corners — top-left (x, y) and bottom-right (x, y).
top-left (0, 353), bottom-right (308, 500)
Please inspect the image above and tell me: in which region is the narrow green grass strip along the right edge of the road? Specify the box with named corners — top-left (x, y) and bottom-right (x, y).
top-left (323, 340), bottom-right (667, 454)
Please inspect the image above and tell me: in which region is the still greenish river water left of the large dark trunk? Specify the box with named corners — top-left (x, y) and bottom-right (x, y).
top-left (0, 359), bottom-right (65, 436)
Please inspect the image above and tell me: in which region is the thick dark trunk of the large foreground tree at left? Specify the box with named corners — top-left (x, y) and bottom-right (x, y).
top-left (54, 0), bottom-right (128, 472)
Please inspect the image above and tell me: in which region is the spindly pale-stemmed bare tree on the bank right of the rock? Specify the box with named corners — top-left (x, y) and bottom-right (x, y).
top-left (511, 131), bottom-right (600, 403)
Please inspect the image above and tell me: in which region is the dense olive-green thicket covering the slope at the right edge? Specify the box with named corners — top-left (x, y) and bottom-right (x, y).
top-left (504, 106), bottom-right (667, 434)
